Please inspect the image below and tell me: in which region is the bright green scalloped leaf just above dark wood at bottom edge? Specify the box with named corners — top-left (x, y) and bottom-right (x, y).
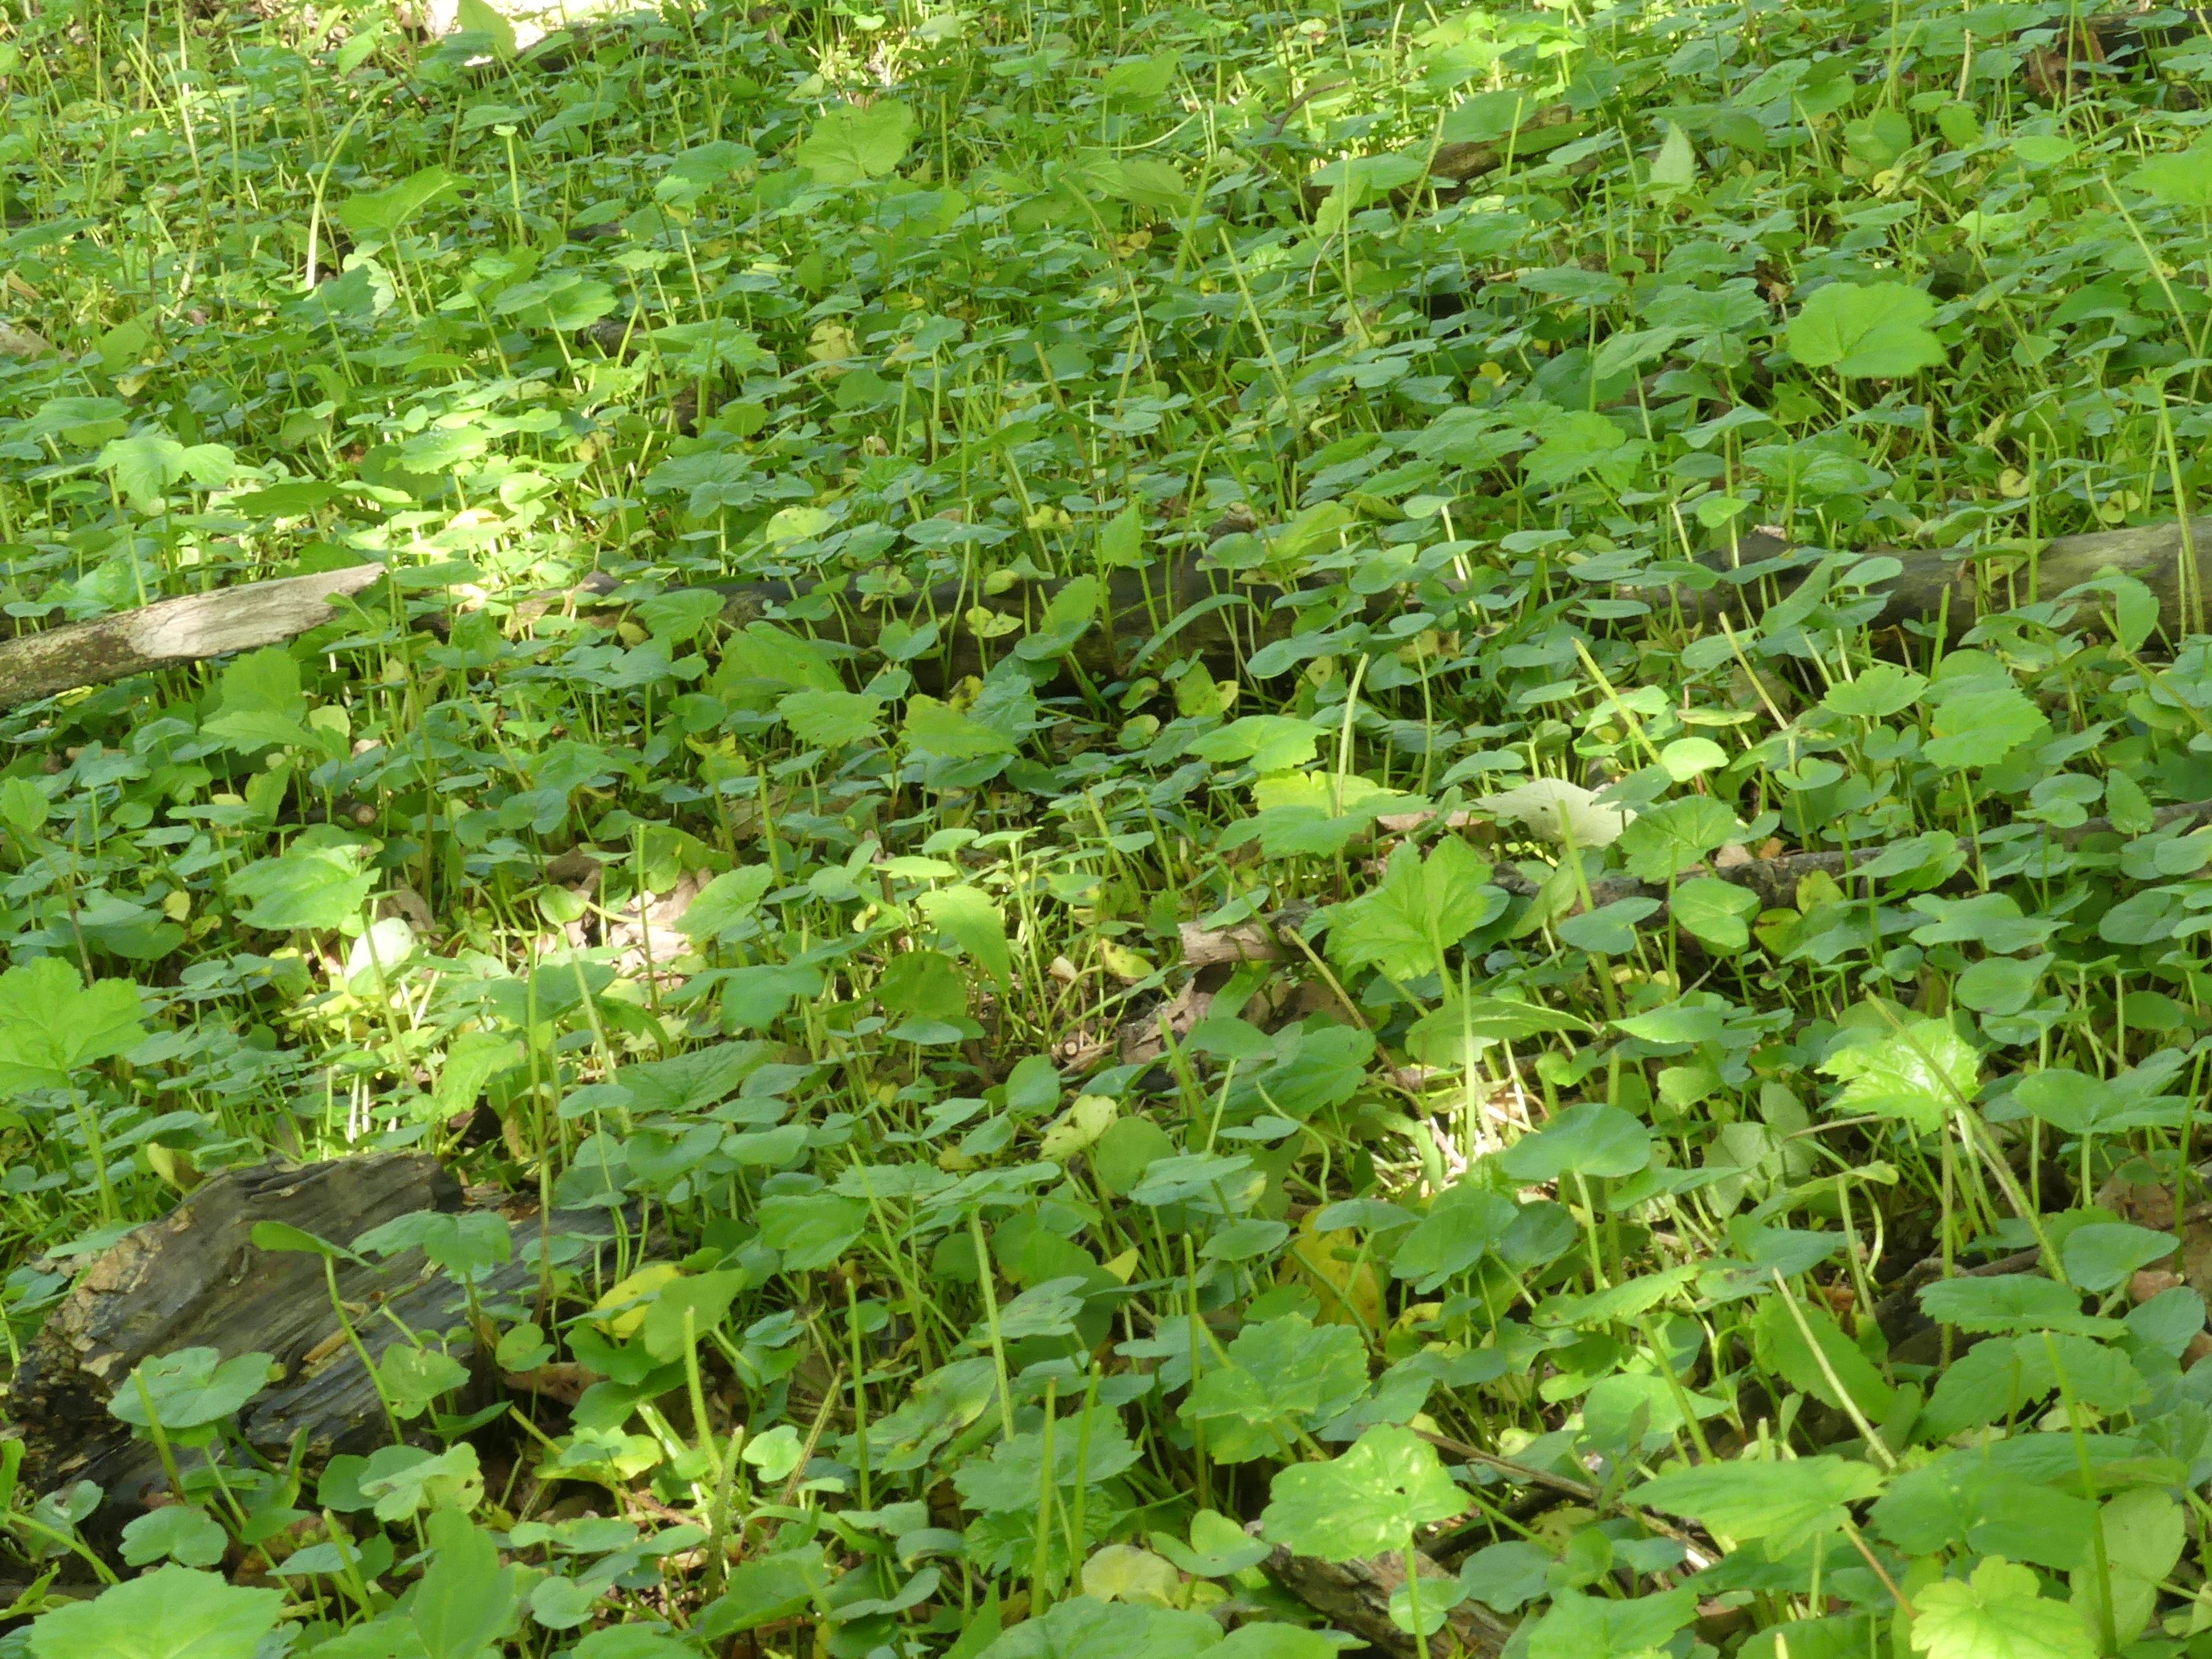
top-left (1260, 1425), bottom-right (1467, 1562)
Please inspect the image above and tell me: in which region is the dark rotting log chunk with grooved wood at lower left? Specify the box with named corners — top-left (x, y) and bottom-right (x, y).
top-left (5, 1153), bottom-right (632, 1544)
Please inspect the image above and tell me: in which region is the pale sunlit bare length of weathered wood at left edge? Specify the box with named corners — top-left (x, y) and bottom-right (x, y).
top-left (0, 564), bottom-right (385, 708)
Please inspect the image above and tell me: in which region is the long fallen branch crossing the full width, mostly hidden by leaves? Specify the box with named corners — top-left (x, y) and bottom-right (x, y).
top-left (0, 517), bottom-right (2212, 708)
